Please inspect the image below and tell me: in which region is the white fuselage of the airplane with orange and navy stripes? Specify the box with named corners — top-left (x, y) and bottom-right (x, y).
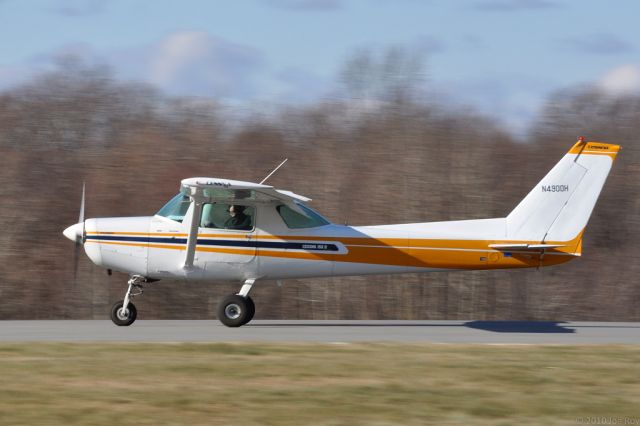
top-left (84, 204), bottom-right (580, 281)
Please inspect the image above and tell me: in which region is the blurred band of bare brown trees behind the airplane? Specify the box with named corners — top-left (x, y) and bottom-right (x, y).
top-left (0, 58), bottom-right (640, 321)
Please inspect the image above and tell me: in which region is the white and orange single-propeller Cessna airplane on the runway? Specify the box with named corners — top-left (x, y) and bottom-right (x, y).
top-left (63, 137), bottom-right (620, 327)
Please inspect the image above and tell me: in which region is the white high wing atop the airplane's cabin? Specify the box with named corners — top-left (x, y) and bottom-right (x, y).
top-left (180, 177), bottom-right (311, 204)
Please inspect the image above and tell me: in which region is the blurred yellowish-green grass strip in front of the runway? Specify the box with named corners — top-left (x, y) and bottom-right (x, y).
top-left (0, 343), bottom-right (640, 425)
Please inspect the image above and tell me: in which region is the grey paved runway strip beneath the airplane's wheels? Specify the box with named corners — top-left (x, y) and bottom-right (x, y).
top-left (0, 320), bottom-right (640, 345)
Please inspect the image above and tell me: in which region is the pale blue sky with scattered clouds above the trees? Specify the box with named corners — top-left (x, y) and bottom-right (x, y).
top-left (0, 0), bottom-right (640, 133)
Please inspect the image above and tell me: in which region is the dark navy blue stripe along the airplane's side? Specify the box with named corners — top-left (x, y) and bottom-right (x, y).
top-left (86, 235), bottom-right (338, 251)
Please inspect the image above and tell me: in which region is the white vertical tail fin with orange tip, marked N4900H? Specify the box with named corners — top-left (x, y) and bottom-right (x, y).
top-left (507, 138), bottom-right (620, 251)
